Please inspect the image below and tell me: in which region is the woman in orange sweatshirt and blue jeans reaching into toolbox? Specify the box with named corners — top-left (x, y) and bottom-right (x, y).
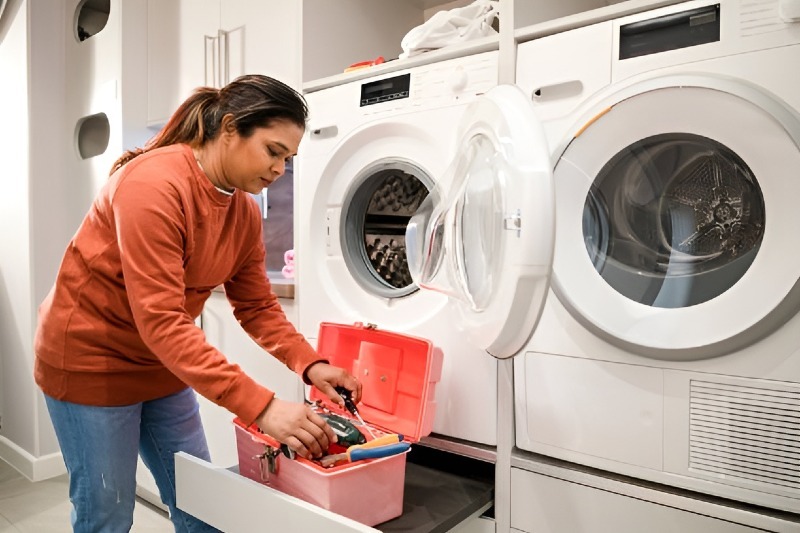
top-left (34, 76), bottom-right (361, 532)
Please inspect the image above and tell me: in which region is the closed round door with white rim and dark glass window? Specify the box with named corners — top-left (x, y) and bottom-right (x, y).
top-left (553, 75), bottom-right (800, 360)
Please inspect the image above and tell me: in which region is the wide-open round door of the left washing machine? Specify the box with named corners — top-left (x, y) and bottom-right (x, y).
top-left (406, 85), bottom-right (555, 358)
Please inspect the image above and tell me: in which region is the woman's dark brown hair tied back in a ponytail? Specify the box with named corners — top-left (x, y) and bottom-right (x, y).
top-left (109, 74), bottom-right (308, 175)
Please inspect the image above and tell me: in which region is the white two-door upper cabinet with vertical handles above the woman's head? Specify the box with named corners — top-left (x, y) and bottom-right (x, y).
top-left (147, 0), bottom-right (300, 128)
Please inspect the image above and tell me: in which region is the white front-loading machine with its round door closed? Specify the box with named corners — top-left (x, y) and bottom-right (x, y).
top-left (514, 0), bottom-right (800, 513)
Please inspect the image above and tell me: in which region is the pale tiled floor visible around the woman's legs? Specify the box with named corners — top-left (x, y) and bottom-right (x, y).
top-left (0, 461), bottom-right (174, 533)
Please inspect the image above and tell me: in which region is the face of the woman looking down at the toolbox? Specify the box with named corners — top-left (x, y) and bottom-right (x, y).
top-left (223, 120), bottom-right (304, 194)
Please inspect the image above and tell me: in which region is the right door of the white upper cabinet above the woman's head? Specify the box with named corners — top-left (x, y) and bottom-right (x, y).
top-left (220, 0), bottom-right (301, 88)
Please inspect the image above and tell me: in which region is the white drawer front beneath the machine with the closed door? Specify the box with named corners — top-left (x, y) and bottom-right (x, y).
top-left (511, 455), bottom-right (798, 533)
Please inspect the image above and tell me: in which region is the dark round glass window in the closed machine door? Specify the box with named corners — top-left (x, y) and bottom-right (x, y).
top-left (583, 133), bottom-right (765, 307)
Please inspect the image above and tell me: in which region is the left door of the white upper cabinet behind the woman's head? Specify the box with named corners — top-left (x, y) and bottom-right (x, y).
top-left (147, 0), bottom-right (223, 127)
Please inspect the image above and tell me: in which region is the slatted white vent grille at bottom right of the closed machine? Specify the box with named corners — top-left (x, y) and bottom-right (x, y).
top-left (689, 380), bottom-right (800, 494)
